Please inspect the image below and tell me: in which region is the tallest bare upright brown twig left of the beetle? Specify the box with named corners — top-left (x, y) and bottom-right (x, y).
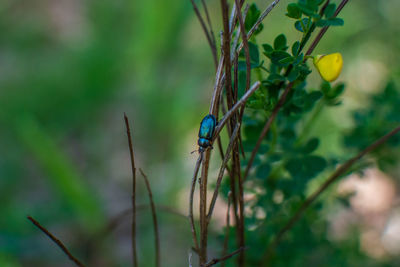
top-left (124, 113), bottom-right (138, 267)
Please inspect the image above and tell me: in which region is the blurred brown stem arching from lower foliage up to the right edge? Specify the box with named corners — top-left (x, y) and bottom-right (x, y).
top-left (264, 126), bottom-right (400, 262)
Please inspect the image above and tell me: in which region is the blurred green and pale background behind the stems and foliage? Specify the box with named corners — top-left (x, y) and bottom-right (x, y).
top-left (0, 0), bottom-right (400, 266)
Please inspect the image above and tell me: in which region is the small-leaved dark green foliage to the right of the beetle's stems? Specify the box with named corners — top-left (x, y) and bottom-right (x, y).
top-left (224, 0), bottom-right (400, 266)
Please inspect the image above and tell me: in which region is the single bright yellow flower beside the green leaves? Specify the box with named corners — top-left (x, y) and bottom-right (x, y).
top-left (314, 53), bottom-right (343, 82)
